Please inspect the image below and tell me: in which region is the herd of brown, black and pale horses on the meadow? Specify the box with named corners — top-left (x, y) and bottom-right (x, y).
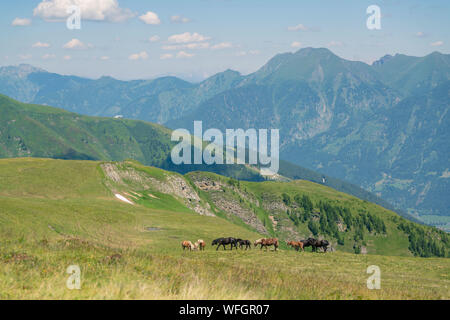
top-left (181, 237), bottom-right (330, 252)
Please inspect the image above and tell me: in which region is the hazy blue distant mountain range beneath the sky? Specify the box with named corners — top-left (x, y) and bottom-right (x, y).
top-left (0, 48), bottom-right (450, 226)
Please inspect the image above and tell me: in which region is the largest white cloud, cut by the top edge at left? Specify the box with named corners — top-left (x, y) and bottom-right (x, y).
top-left (33, 0), bottom-right (135, 22)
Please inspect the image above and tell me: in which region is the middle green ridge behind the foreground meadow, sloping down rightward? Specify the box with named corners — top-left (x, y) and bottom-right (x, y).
top-left (0, 92), bottom-right (414, 221)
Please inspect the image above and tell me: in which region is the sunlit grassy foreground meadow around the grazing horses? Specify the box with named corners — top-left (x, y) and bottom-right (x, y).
top-left (0, 158), bottom-right (450, 299)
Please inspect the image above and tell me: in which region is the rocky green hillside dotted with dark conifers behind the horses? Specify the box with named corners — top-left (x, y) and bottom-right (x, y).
top-left (187, 172), bottom-right (450, 257)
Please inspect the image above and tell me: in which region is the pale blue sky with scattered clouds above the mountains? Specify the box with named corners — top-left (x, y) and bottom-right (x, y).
top-left (0, 0), bottom-right (450, 81)
